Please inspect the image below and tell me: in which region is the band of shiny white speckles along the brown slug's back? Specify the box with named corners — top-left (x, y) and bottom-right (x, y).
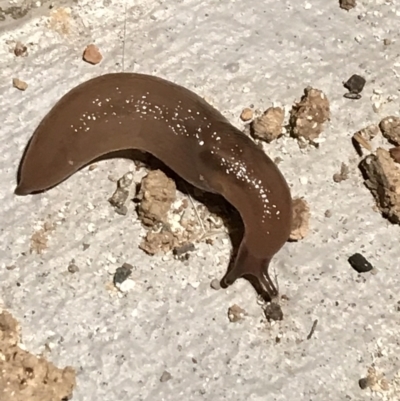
top-left (71, 88), bottom-right (281, 227)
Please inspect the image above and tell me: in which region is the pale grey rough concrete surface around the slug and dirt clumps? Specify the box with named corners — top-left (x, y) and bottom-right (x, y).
top-left (0, 0), bottom-right (400, 401)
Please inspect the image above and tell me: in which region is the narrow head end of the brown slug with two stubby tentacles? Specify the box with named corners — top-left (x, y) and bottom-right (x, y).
top-left (222, 241), bottom-right (278, 302)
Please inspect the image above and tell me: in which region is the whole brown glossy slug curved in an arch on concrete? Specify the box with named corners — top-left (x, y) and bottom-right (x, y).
top-left (15, 73), bottom-right (292, 300)
